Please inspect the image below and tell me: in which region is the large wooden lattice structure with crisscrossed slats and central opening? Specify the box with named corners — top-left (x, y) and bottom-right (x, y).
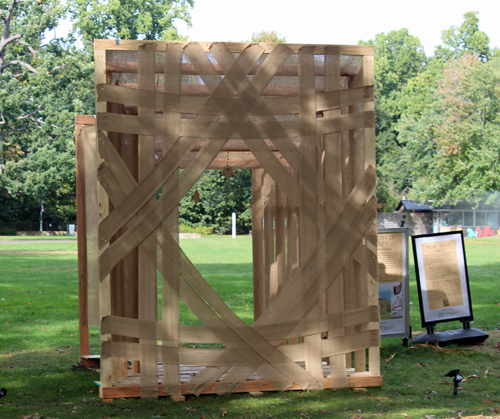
top-left (76, 40), bottom-right (382, 400)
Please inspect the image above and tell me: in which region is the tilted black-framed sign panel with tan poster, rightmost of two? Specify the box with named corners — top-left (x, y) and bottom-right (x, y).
top-left (412, 231), bottom-right (474, 327)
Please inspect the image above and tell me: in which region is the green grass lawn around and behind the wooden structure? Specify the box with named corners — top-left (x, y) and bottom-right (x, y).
top-left (0, 236), bottom-right (500, 419)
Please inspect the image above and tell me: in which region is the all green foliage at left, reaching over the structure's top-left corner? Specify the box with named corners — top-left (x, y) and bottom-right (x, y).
top-left (0, 0), bottom-right (193, 225)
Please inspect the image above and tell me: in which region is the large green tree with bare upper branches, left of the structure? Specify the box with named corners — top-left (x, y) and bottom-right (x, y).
top-left (0, 0), bottom-right (94, 228)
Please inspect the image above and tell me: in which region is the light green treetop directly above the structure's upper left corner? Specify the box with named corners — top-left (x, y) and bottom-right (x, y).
top-left (69, 0), bottom-right (194, 45)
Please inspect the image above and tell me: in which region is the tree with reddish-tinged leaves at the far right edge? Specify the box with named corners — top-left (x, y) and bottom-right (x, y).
top-left (400, 54), bottom-right (500, 203)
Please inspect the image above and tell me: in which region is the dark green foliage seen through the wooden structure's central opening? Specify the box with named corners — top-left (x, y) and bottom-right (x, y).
top-left (179, 169), bottom-right (252, 234)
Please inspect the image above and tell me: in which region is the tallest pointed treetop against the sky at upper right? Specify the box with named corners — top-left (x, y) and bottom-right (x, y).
top-left (435, 12), bottom-right (492, 61)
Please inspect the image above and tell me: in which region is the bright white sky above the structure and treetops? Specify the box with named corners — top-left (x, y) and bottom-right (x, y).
top-left (173, 0), bottom-right (500, 55)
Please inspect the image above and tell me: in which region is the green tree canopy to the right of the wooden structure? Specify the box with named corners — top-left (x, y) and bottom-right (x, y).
top-left (361, 12), bottom-right (500, 211)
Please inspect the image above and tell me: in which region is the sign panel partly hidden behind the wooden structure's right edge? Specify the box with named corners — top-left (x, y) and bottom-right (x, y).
top-left (377, 227), bottom-right (411, 338)
